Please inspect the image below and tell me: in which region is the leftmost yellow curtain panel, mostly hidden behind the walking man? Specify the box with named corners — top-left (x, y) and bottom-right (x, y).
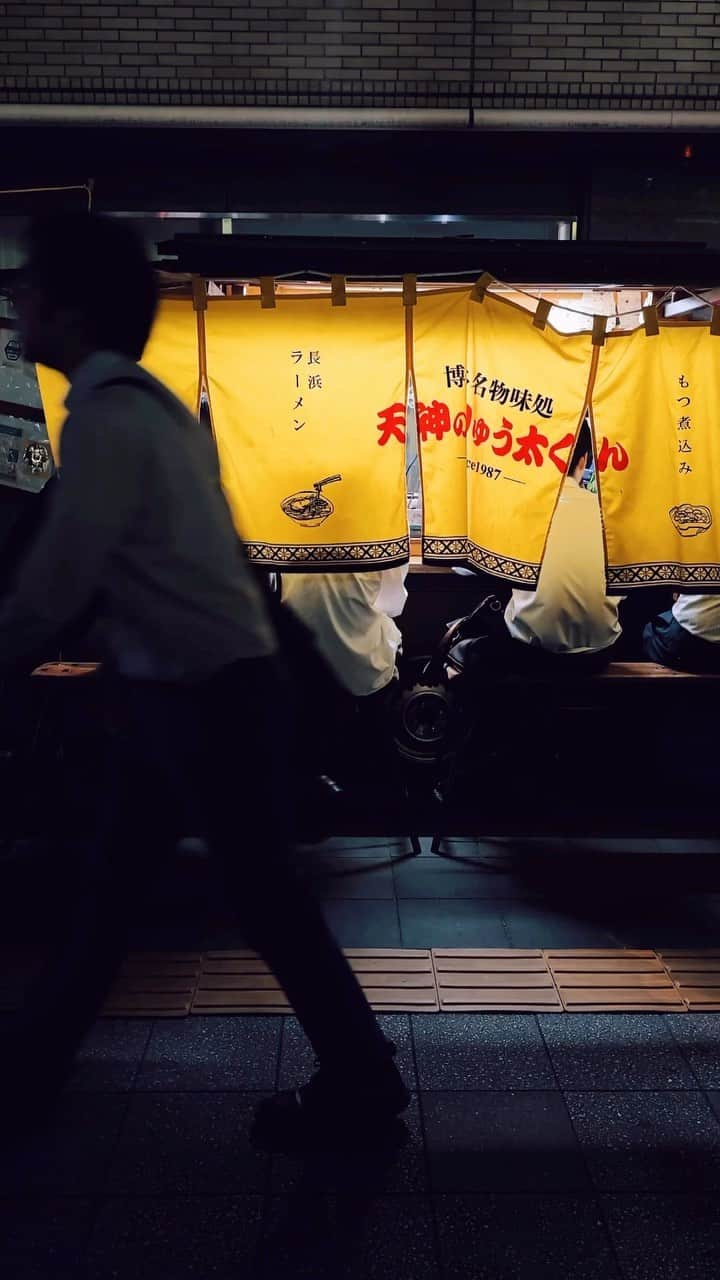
top-left (37, 298), bottom-right (200, 462)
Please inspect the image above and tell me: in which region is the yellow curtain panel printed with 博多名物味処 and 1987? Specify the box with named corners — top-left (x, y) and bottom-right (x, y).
top-left (415, 294), bottom-right (592, 588)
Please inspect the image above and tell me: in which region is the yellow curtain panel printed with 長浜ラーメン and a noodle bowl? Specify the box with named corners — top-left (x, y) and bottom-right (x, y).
top-left (205, 297), bottom-right (409, 568)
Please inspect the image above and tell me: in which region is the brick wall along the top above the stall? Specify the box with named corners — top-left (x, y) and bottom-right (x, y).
top-left (0, 0), bottom-right (720, 110)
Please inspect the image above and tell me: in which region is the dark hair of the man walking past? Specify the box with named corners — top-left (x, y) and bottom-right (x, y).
top-left (26, 214), bottom-right (158, 360)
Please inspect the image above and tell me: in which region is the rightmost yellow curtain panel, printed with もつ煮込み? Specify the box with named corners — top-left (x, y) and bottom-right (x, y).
top-left (592, 325), bottom-right (720, 589)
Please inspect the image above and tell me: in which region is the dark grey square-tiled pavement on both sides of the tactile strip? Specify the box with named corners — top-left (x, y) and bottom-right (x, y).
top-left (0, 841), bottom-right (720, 1280)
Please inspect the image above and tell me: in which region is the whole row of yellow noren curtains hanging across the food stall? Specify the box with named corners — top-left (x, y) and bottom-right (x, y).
top-left (22, 261), bottom-right (720, 604)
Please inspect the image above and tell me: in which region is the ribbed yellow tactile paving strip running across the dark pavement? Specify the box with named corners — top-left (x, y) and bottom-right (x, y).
top-left (7, 946), bottom-right (720, 1018)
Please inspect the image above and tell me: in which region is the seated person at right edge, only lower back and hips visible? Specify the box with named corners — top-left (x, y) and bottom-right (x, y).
top-left (643, 595), bottom-right (720, 672)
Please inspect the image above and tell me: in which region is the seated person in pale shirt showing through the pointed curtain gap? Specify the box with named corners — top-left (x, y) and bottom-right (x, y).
top-left (505, 422), bottom-right (621, 672)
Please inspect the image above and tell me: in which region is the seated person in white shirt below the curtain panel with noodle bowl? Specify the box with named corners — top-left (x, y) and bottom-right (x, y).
top-left (282, 564), bottom-right (407, 776)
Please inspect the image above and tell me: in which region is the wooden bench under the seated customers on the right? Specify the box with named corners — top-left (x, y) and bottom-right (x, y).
top-left (422, 662), bottom-right (720, 852)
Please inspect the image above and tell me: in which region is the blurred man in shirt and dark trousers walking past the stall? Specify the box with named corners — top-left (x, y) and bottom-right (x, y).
top-left (0, 215), bottom-right (409, 1138)
